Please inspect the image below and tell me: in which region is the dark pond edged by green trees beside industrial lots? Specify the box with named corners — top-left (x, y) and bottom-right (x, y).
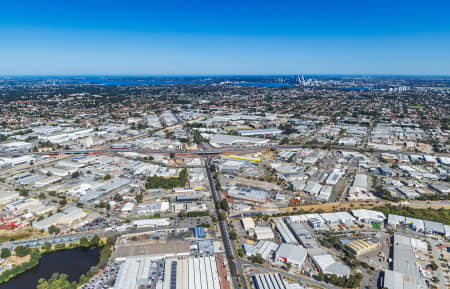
top-left (0, 247), bottom-right (101, 289)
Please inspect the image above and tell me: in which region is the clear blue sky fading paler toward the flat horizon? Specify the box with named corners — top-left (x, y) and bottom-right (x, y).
top-left (0, 0), bottom-right (450, 75)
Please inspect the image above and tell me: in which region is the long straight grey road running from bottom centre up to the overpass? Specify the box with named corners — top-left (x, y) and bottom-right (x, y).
top-left (206, 158), bottom-right (248, 289)
